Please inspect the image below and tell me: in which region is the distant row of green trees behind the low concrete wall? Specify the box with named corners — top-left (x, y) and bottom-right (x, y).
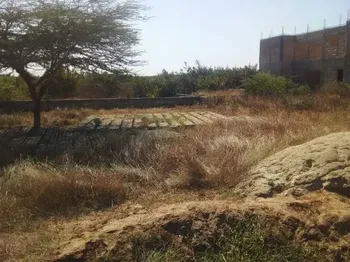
top-left (0, 62), bottom-right (257, 100)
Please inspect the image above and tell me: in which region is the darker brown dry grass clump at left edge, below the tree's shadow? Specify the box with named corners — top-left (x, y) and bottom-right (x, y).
top-left (0, 161), bottom-right (125, 231)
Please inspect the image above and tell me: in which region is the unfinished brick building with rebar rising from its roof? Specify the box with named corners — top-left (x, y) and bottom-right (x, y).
top-left (260, 21), bottom-right (350, 85)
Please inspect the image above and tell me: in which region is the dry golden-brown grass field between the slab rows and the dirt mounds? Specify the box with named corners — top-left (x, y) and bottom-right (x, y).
top-left (0, 90), bottom-right (350, 257)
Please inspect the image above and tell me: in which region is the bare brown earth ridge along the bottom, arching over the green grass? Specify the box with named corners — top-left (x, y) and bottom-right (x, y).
top-left (51, 191), bottom-right (350, 261)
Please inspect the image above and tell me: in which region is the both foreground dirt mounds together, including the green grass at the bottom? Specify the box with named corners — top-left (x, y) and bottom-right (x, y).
top-left (30, 132), bottom-right (350, 262)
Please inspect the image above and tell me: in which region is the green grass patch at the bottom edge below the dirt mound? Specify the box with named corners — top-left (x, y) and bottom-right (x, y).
top-left (133, 219), bottom-right (325, 262)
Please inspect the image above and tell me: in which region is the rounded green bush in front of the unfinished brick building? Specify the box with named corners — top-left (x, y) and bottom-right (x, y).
top-left (242, 73), bottom-right (310, 96)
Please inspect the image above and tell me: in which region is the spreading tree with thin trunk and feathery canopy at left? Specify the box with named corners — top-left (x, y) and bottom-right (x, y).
top-left (0, 0), bottom-right (146, 127)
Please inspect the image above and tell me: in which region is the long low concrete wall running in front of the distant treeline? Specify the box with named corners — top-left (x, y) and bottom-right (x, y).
top-left (0, 96), bottom-right (202, 112)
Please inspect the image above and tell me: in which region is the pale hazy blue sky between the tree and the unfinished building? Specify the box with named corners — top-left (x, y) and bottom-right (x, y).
top-left (138, 0), bottom-right (350, 75)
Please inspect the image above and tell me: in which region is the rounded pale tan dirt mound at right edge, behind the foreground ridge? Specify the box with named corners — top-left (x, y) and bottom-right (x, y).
top-left (237, 132), bottom-right (350, 197)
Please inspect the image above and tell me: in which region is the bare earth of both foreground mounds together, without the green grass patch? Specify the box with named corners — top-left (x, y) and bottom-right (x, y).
top-left (0, 132), bottom-right (350, 262)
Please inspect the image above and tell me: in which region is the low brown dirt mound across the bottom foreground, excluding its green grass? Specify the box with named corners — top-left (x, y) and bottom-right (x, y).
top-left (52, 191), bottom-right (350, 261)
